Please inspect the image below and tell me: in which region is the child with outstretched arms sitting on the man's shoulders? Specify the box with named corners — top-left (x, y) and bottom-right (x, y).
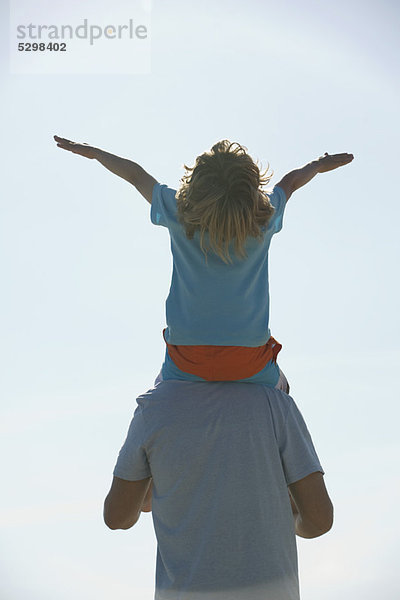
top-left (54, 136), bottom-right (353, 393)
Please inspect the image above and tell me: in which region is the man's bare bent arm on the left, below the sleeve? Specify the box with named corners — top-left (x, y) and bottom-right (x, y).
top-left (104, 477), bottom-right (151, 529)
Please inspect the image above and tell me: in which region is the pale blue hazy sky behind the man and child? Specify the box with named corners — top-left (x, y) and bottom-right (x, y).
top-left (0, 0), bottom-right (400, 600)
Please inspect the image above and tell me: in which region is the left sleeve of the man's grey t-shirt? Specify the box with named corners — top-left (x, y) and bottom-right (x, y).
top-left (114, 407), bottom-right (151, 481)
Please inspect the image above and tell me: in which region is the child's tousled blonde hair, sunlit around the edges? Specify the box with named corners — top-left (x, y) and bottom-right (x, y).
top-left (176, 140), bottom-right (274, 263)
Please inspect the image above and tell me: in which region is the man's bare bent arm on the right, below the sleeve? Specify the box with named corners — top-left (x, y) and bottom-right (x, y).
top-left (289, 472), bottom-right (333, 538)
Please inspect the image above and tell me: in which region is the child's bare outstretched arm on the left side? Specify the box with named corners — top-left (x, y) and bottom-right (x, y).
top-left (54, 135), bottom-right (158, 204)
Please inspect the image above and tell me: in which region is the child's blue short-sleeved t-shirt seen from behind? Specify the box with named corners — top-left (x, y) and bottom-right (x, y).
top-left (151, 183), bottom-right (286, 347)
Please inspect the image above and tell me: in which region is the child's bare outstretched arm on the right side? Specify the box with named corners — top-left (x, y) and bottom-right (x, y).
top-left (276, 152), bottom-right (354, 200)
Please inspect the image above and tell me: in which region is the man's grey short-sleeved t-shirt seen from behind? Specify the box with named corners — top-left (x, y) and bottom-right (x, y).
top-left (114, 380), bottom-right (323, 600)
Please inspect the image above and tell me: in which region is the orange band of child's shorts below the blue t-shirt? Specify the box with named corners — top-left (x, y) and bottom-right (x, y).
top-left (163, 329), bottom-right (282, 381)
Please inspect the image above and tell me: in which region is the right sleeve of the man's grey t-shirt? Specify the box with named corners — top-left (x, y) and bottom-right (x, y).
top-left (279, 398), bottom-right (324, 485)
